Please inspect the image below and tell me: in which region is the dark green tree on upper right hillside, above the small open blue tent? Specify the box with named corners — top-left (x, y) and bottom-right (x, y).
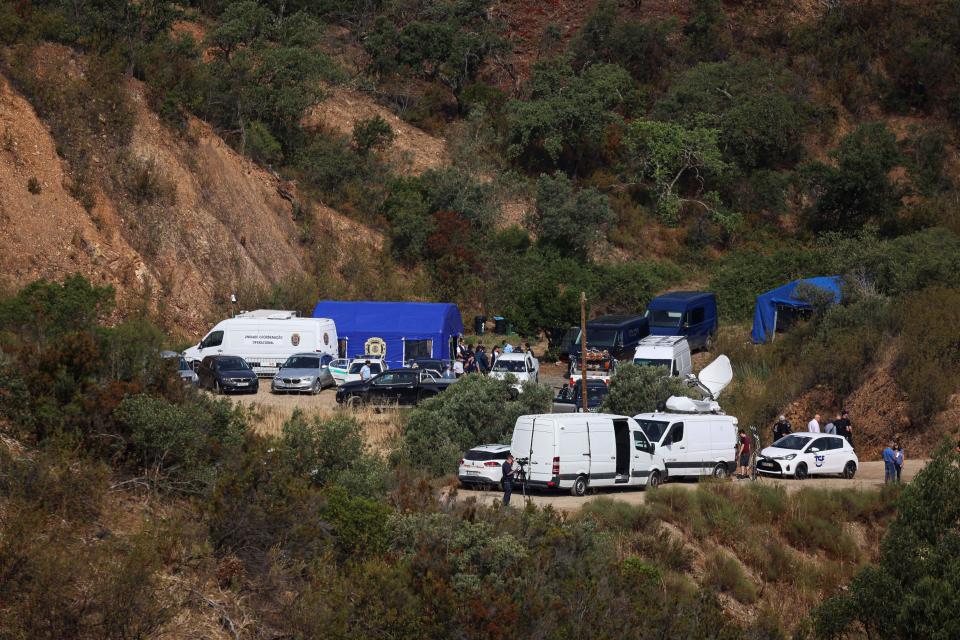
top-left (801, 123), bottom-right (902, 232)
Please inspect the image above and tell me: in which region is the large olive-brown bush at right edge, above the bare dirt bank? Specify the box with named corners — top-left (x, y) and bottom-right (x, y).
top-left (896, 287), bottom-right (960, 424)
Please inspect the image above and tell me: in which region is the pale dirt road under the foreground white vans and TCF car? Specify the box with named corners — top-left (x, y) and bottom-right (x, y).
top-left (459, 460), bottom-right (927, 511)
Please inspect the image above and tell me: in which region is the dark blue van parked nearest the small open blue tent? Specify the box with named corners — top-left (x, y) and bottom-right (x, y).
top-left (640, 291), bottom-right (717, 350)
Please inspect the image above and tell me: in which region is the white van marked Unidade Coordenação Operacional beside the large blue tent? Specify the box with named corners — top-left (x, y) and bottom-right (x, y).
top-left (183, 309), bottom-right (337, 377)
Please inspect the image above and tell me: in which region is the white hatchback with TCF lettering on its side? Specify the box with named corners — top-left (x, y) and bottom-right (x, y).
top-left (757, 433), bottom-right (860, 480)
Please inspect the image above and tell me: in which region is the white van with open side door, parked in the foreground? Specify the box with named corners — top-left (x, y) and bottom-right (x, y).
top-left (510, 413), bottom-right (666, 496)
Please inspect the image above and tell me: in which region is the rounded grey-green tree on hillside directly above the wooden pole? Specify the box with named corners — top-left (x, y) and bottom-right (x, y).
top-left (527, 171), bottom-right (614, 260)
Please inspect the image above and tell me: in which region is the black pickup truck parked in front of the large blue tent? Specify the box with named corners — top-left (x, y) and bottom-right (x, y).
top-left (337, 368), bottom-right (456, 407)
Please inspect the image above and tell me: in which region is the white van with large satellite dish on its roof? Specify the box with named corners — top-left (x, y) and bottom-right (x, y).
top-left (633, 356), bottom-right (737, 478)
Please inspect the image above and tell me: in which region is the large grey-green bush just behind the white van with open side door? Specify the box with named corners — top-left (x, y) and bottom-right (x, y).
top-left (403, 375), bottom-right (553, 475)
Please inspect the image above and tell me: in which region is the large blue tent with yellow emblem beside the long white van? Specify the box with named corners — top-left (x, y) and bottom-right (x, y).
top-left (313, 300), bottom-right (463, 367)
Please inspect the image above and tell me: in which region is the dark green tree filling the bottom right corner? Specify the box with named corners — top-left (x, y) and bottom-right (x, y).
top-left (814, 448), bottom-right (960, 640)
